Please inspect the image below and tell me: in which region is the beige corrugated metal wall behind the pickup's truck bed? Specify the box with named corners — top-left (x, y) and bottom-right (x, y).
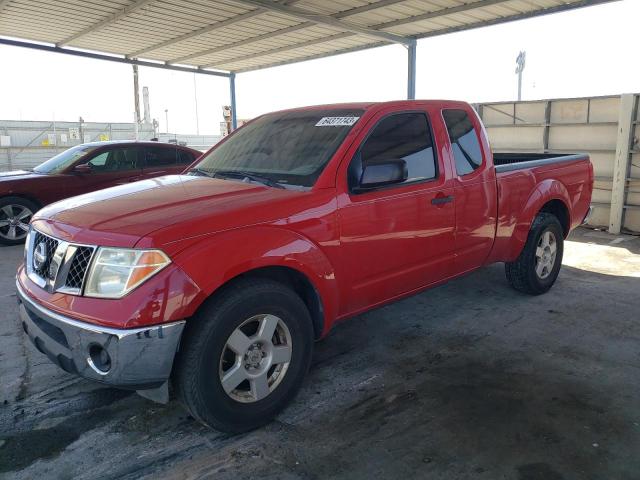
top-left (476, 94), bottom-right (640, 232)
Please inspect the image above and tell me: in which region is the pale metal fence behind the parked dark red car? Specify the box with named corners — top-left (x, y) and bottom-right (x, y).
top-left (0, 120), bottom-right (222, 171)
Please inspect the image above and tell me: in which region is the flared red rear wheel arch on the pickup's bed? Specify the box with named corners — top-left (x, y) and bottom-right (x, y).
top-left (509, 179), bottom-right (571, 259)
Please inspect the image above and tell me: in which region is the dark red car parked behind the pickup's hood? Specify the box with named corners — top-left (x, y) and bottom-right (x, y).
top-left (0, 141), bottom-right (201, 245)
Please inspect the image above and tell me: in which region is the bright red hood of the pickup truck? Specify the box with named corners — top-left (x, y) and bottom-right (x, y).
top-left (34, 175), bottom-right (308, 251)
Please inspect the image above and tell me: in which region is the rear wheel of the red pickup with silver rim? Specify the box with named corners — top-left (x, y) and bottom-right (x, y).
top-left (505, 212), bottom-right (564, 295)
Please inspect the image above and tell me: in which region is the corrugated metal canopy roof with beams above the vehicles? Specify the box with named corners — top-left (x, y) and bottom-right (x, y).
top-left (0, 0), bottom-right (615, 76)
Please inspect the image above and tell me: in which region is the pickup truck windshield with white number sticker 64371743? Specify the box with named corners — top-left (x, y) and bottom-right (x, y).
top-left (192, 109), bottom-right (362, 187)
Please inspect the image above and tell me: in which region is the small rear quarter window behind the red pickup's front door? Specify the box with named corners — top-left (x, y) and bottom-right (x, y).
top-left (442, 110), bottom-right (482, 176)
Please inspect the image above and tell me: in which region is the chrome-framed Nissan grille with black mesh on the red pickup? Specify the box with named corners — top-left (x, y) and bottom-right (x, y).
top-left (26, 230), bottom-right (96, 295)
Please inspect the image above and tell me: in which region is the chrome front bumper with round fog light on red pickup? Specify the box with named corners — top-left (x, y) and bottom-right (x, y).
top-left (16, 283), bottom-right (185, 390)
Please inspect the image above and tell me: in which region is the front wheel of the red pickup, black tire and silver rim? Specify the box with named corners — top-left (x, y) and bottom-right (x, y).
top-left (172, 279), bottom-right (314, 433)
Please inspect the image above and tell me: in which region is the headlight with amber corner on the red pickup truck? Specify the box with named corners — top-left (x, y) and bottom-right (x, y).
top-left (85, 247), bottom-right (171, 298)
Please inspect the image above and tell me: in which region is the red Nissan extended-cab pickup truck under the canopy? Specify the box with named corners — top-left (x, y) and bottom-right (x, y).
top-left (17, 101), bottom-right (593, 432)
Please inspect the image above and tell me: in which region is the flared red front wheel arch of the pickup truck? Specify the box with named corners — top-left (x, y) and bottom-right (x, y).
top-left (172, 226), bottom-right (338, 331)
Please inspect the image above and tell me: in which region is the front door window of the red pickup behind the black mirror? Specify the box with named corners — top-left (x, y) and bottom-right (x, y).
top-left (349, 113), bottom-right (436, 188)
